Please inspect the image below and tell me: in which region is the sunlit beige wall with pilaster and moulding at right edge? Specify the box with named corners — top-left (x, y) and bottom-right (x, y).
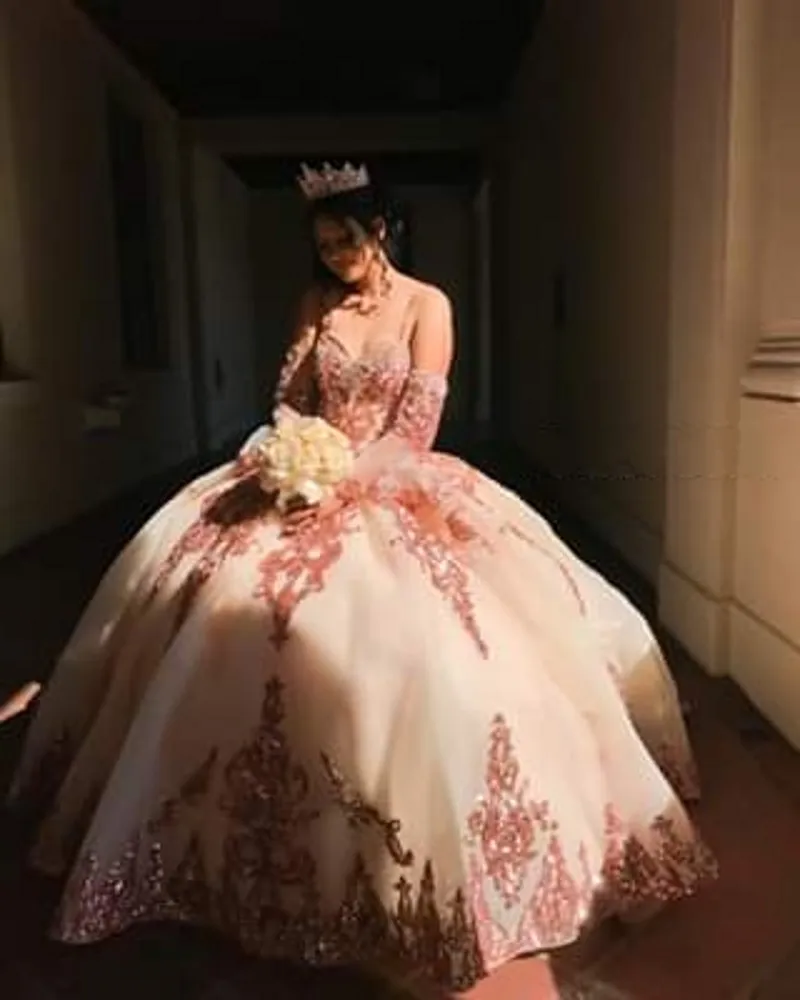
top-left (659, 0), bottom-right (800, 746)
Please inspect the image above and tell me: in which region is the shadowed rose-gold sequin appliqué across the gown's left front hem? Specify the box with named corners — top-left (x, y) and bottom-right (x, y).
top-left (57, 678), bottom-right (485, 989)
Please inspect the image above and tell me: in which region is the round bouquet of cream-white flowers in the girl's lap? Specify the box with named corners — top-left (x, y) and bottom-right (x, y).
top-left (255, 411), bottom-right (354, 513)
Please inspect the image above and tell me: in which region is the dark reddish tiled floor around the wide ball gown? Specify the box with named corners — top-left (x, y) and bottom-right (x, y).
top-left (0, 450), bottom-right (800, 1000)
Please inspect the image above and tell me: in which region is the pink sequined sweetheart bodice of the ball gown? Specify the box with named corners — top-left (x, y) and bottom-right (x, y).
top-left (316, 331), bottom-right (410, 451)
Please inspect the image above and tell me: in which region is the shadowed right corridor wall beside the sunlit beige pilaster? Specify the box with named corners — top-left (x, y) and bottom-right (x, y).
top-left (506, 0), bottom-right (675, 578)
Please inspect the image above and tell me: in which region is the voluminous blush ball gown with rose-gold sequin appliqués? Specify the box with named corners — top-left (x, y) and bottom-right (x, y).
top-left (12, 320), bottom-right (714, 988)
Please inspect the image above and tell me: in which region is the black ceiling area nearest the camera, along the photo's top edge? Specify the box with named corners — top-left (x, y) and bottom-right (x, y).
top-left (75, 0), bottom-right (543, 118)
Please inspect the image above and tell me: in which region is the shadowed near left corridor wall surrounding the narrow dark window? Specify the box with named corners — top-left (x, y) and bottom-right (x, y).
top-left (0, 0), bottom-right (194, 550)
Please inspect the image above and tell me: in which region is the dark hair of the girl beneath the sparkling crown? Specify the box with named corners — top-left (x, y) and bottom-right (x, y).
top-left (308, 172), bottom-right (409, 286)
